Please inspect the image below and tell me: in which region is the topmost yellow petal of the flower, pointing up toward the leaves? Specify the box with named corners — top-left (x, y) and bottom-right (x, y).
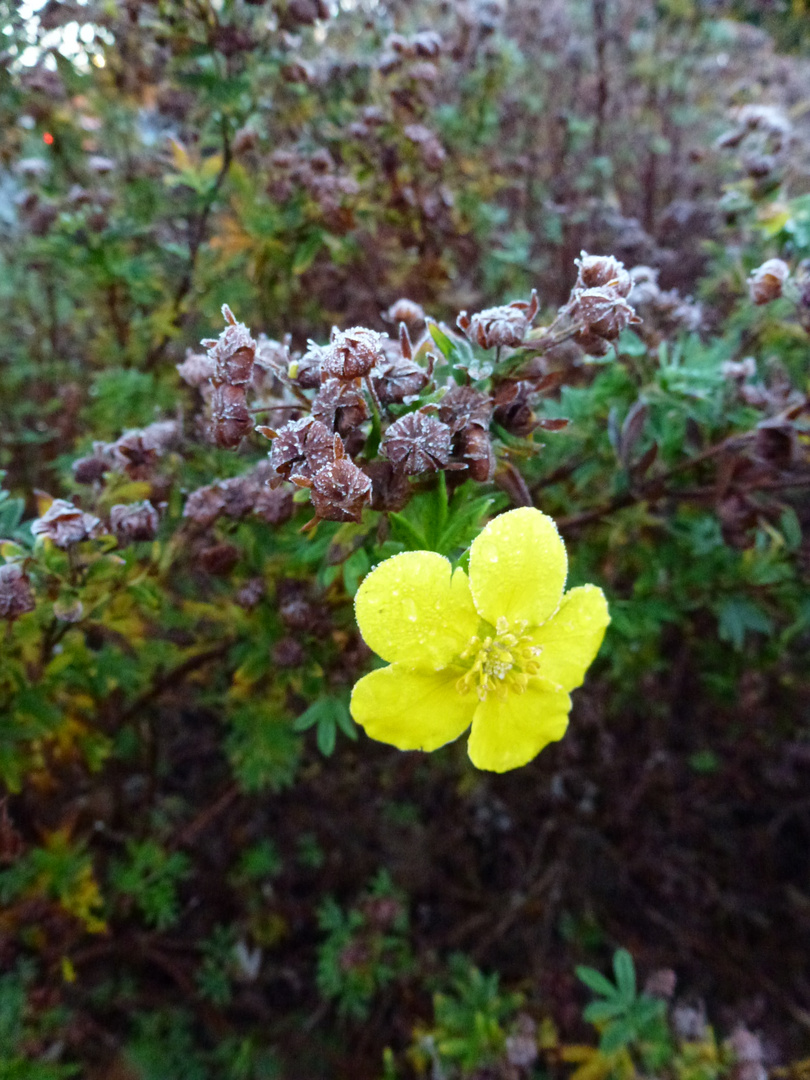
top-left (470, 507), bottom-right (568, 626)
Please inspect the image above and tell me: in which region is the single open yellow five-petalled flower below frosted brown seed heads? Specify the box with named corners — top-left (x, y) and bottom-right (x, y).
top-left (351, 508), bottom-right (610, 772)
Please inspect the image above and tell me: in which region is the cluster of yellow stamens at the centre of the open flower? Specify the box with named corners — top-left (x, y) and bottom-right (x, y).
top-left (456, 618), bottom-right (542, 701)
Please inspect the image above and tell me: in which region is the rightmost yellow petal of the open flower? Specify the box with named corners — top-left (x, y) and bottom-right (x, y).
top-left (531, 585), bottom-right (610, 690)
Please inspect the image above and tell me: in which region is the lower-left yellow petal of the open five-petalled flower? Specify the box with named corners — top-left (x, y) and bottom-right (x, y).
top-left (351, 664), bottom-right (478, 751)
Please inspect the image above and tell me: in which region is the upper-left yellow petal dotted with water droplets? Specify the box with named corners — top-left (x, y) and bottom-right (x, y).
top-left (354, 551), bottom-right (478, 671)
